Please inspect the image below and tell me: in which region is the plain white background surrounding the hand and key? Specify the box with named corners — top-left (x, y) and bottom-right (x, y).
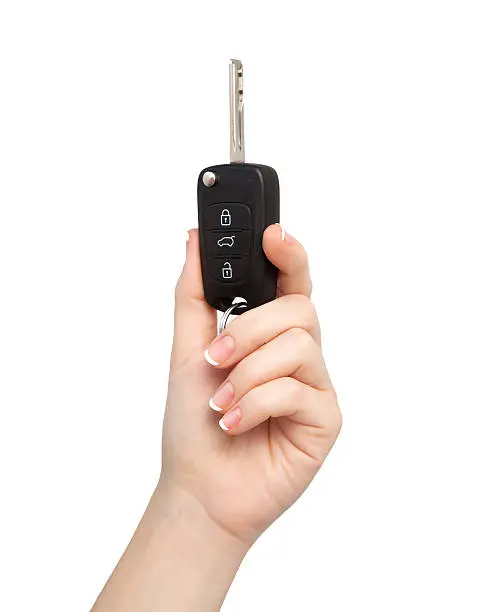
top-left (0, 0), bottom-right (477, 612)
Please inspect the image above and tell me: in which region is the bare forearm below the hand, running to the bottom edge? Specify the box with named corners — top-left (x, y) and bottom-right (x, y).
top-left (92, 483), bottom-right (246, 612)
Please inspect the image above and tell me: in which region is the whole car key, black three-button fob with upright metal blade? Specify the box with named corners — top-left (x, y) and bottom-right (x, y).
top-left (197, 60), bottom-right (280, 312)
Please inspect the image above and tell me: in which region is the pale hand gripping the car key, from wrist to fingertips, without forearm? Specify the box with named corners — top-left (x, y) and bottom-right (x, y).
top-left (160, 225), bottom-right (341, 546)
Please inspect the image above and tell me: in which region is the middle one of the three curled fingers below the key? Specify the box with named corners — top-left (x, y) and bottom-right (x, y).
top-left (209, 328), bottom-right (332, 412)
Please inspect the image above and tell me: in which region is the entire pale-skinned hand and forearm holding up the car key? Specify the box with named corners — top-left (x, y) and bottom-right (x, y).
top-left (93, 225), bottom-right (341, 612)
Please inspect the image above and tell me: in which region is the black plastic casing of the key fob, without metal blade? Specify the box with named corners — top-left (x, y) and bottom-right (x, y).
top-left (197, 163), bottom-right (280, 312)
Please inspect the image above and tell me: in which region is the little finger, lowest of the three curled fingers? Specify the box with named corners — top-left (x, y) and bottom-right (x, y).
top-left (219, 377), bottom-right (341, 442)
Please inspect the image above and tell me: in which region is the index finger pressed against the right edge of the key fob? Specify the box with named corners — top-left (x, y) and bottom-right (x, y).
top-left (263, 224), bottom-right (312, 297)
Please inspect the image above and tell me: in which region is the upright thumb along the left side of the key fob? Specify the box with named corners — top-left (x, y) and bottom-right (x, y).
top-left (171, 229), bottom-right (217, 369)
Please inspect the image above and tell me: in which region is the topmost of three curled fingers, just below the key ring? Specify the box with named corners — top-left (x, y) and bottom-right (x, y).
top-left (205, 295), bottom-right (320, 368)
